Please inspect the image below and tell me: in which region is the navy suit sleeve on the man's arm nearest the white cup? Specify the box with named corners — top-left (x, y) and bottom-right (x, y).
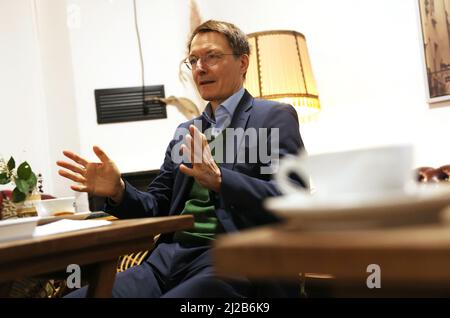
top-left (220, 104), bottom-right (304, 223)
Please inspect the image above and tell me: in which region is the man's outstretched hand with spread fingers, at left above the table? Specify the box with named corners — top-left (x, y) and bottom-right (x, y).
top-left (56, 146), bottom-right (125, 203)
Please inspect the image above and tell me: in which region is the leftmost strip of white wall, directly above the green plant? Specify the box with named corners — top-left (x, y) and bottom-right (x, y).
top-left (0, 0), bottom-right (53, 193)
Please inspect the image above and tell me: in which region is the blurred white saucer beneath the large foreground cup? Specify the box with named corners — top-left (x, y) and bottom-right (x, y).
top-left (265, 184), bottom-right (450, 229)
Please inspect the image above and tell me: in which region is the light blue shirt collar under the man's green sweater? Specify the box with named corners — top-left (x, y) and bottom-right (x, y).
top-left (203, 87), bottom-right (245, 137)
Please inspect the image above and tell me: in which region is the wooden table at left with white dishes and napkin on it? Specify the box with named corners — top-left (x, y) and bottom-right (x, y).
top-left (0, 215), bottom-right (194, 297)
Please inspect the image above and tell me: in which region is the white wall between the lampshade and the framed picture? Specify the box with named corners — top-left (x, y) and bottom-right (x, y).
top-left (198, 0), bottom-right (450, 166)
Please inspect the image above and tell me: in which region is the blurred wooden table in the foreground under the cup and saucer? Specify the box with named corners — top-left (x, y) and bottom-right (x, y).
top-left (213, 224), bottom-right (450, 296)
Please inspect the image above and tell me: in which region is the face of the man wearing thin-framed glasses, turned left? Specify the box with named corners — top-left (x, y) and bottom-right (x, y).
top-left (189, 32), bottom-right (248, 109)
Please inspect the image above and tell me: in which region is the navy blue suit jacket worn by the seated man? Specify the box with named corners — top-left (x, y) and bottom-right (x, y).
top-left (105, 91), bottom-right (303, 232)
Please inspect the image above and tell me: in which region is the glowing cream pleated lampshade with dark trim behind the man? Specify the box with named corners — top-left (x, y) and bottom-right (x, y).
top-left (244, 31), bottom-right (320, 121)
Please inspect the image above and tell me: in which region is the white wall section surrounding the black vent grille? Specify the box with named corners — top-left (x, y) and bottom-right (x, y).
top-left (68, 0), bottom-right (200, 172)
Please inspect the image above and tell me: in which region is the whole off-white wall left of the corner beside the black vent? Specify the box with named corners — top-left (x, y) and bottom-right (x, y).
top-left (0, 0), bottom-right (85, 204)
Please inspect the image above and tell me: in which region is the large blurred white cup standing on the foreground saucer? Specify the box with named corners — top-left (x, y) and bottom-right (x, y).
top-left (275, 145), bottom-right (414, 199)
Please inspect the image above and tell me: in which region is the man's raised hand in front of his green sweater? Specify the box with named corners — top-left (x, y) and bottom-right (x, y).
top-left (180, 125), bottom-right (222, 193)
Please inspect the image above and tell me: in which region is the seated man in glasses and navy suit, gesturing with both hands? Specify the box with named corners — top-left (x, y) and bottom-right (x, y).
top-left (57, 20), bottom-right (303, 297)
